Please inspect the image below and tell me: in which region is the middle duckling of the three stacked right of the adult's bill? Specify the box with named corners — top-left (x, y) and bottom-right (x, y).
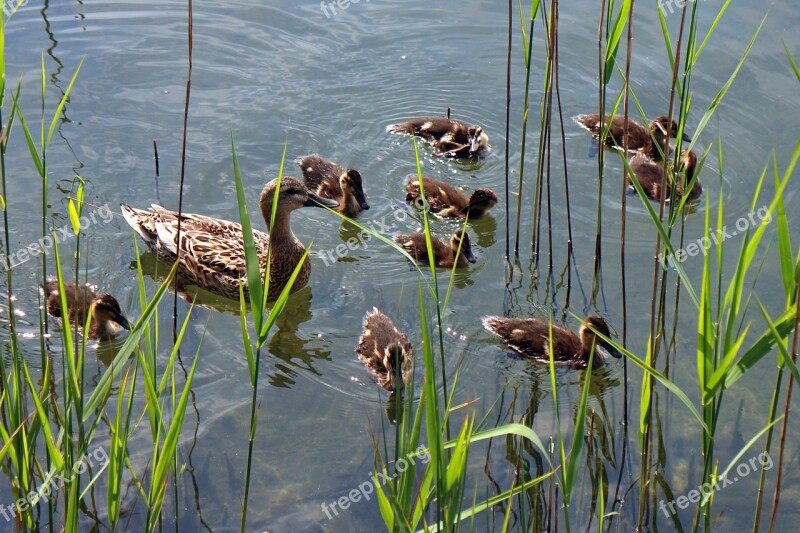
top-left (406, 174), bottom-right (497, 218)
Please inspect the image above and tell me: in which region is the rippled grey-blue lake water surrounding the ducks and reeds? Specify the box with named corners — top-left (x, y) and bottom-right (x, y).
top-left (0, 0), bottom-right (800, 532)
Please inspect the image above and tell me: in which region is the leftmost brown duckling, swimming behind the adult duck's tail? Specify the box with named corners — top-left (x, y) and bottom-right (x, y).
top-left (42, 279), bottom-right (131, 340)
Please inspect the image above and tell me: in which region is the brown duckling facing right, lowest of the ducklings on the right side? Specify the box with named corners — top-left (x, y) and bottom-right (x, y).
top-left (483, 315), bottom-right (621, 368)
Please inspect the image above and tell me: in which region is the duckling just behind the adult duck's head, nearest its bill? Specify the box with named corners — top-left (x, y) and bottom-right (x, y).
top-left (297, 154), bottom-right (369, 217)
